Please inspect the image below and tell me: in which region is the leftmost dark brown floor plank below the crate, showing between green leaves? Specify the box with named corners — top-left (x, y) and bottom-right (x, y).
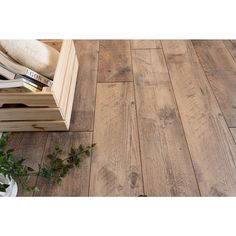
top-left (9, 132), bottom-right (48, 196)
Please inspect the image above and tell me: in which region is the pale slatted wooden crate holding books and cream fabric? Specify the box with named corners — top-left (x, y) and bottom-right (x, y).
top-left (0, 40), bottom-right (79, 132)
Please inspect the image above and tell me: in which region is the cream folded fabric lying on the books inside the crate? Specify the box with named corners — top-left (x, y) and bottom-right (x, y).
top-left (0, 40), bottom-right (59, 78)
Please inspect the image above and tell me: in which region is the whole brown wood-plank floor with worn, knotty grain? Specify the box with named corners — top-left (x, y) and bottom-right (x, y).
top-left (8, 40), bottom-right (236, 196)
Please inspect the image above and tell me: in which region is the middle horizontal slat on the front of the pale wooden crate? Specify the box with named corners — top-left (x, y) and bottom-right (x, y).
top-left (0, 108), bottom-right (62, 121)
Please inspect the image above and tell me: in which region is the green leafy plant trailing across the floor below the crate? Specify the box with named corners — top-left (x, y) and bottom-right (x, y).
top-left (0, 133), bottom-right (96, 195)
